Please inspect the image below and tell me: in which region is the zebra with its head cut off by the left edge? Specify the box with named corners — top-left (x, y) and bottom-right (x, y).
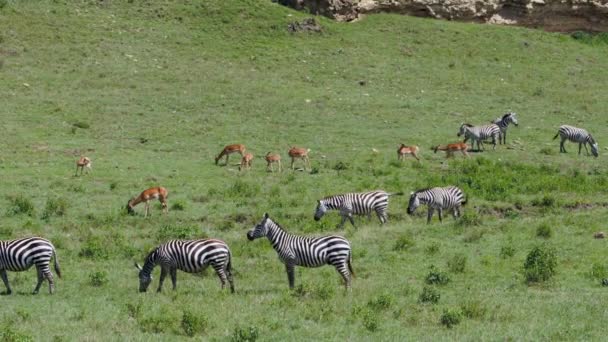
top-left (0, 237), bottom-right (61, 294)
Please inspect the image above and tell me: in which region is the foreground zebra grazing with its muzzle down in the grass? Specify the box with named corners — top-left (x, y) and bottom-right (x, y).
top-left (135, 239), bottom-right (234, 293)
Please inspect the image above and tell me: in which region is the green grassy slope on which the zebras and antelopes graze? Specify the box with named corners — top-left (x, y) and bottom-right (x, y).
top-left (0, 0), bottom-right (608, 341)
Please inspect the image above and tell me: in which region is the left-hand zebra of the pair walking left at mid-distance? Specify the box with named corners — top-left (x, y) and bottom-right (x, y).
top-left (315, 190), bottom-right (403, 228)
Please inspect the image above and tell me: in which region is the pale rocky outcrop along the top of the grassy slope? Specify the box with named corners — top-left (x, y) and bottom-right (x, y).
top-left (276, 0), bottom-right (608, 32)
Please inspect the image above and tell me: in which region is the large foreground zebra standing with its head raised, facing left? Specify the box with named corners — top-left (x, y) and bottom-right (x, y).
top-left (247, 214), bottom-right (355, 289)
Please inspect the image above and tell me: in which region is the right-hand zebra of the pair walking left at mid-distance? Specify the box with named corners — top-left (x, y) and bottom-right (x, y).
top-left (407, 186), bottom-right (467, 223)
